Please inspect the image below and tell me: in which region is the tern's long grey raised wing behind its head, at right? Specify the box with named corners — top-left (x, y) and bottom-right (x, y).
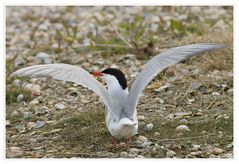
top-left (125, 43), bottom-right (225, 118)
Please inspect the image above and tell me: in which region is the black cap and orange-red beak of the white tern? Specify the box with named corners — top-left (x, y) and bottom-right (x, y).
top-left (91, 68), bottom-right (127, 89)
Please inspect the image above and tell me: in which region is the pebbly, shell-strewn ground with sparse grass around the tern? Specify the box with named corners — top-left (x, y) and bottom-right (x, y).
top-left (6, 6), bottom-right (233, 158)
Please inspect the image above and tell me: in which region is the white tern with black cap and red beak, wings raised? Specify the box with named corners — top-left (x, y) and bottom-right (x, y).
top-left (12, 43), bottom-right (225, 147)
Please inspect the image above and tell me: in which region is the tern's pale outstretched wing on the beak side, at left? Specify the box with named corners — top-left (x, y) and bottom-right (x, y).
top-left (11, 63), bottom-right (117, 119)
